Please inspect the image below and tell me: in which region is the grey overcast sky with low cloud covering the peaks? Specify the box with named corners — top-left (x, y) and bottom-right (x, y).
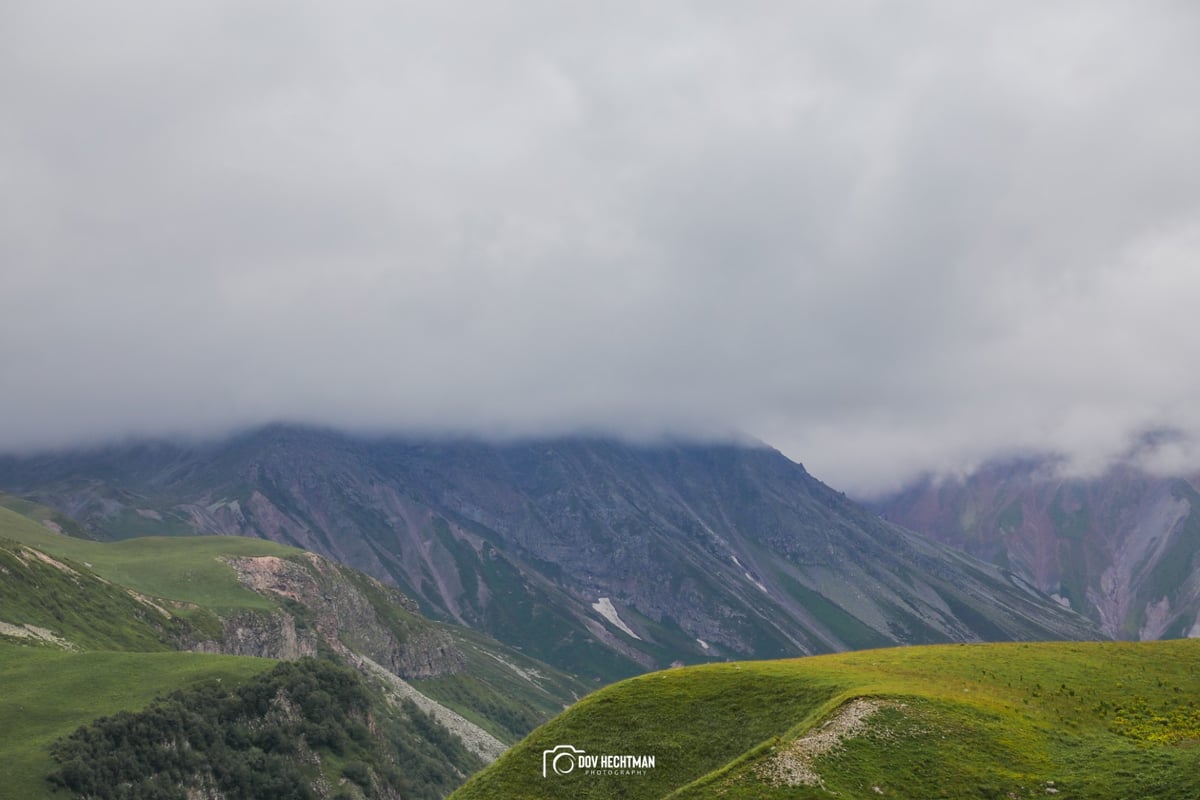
top-left (0, 0), bottom-right (1200, 492)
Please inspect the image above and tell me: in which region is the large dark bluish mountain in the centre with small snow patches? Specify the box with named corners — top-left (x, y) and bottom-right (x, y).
top-left (0, 426), bottom-right (1097, 679)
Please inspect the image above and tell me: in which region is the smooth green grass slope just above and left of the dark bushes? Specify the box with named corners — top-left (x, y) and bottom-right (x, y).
top-left (0, 643), bottom-right (276, 800)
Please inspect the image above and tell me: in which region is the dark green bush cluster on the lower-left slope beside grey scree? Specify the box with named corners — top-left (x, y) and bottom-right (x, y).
top-left (48, 658), bottom-right (478, 800)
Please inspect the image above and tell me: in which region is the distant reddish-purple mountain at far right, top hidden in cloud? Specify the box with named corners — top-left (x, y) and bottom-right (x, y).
top-left (874, 459), bottom-right (1200, 639)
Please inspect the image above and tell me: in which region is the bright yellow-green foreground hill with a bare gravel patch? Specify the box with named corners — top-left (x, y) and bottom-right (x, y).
top-left (454, 640), bottom-right (1200, 800)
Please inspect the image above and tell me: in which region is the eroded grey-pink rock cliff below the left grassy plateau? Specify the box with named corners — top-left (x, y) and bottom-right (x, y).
top-left (187, 553), bottom-right (466, 679)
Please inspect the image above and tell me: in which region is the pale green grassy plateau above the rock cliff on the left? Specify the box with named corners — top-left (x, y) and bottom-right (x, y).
top-left (0, 509), bottom-right (301, 610)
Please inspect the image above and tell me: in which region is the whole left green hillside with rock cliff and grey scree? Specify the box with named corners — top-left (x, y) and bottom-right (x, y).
top-left (0, 498), bottom-right (583, 800)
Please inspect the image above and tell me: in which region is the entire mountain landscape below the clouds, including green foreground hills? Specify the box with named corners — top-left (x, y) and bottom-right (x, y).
top-left (7, 425), bottom-right (1200, 799)
